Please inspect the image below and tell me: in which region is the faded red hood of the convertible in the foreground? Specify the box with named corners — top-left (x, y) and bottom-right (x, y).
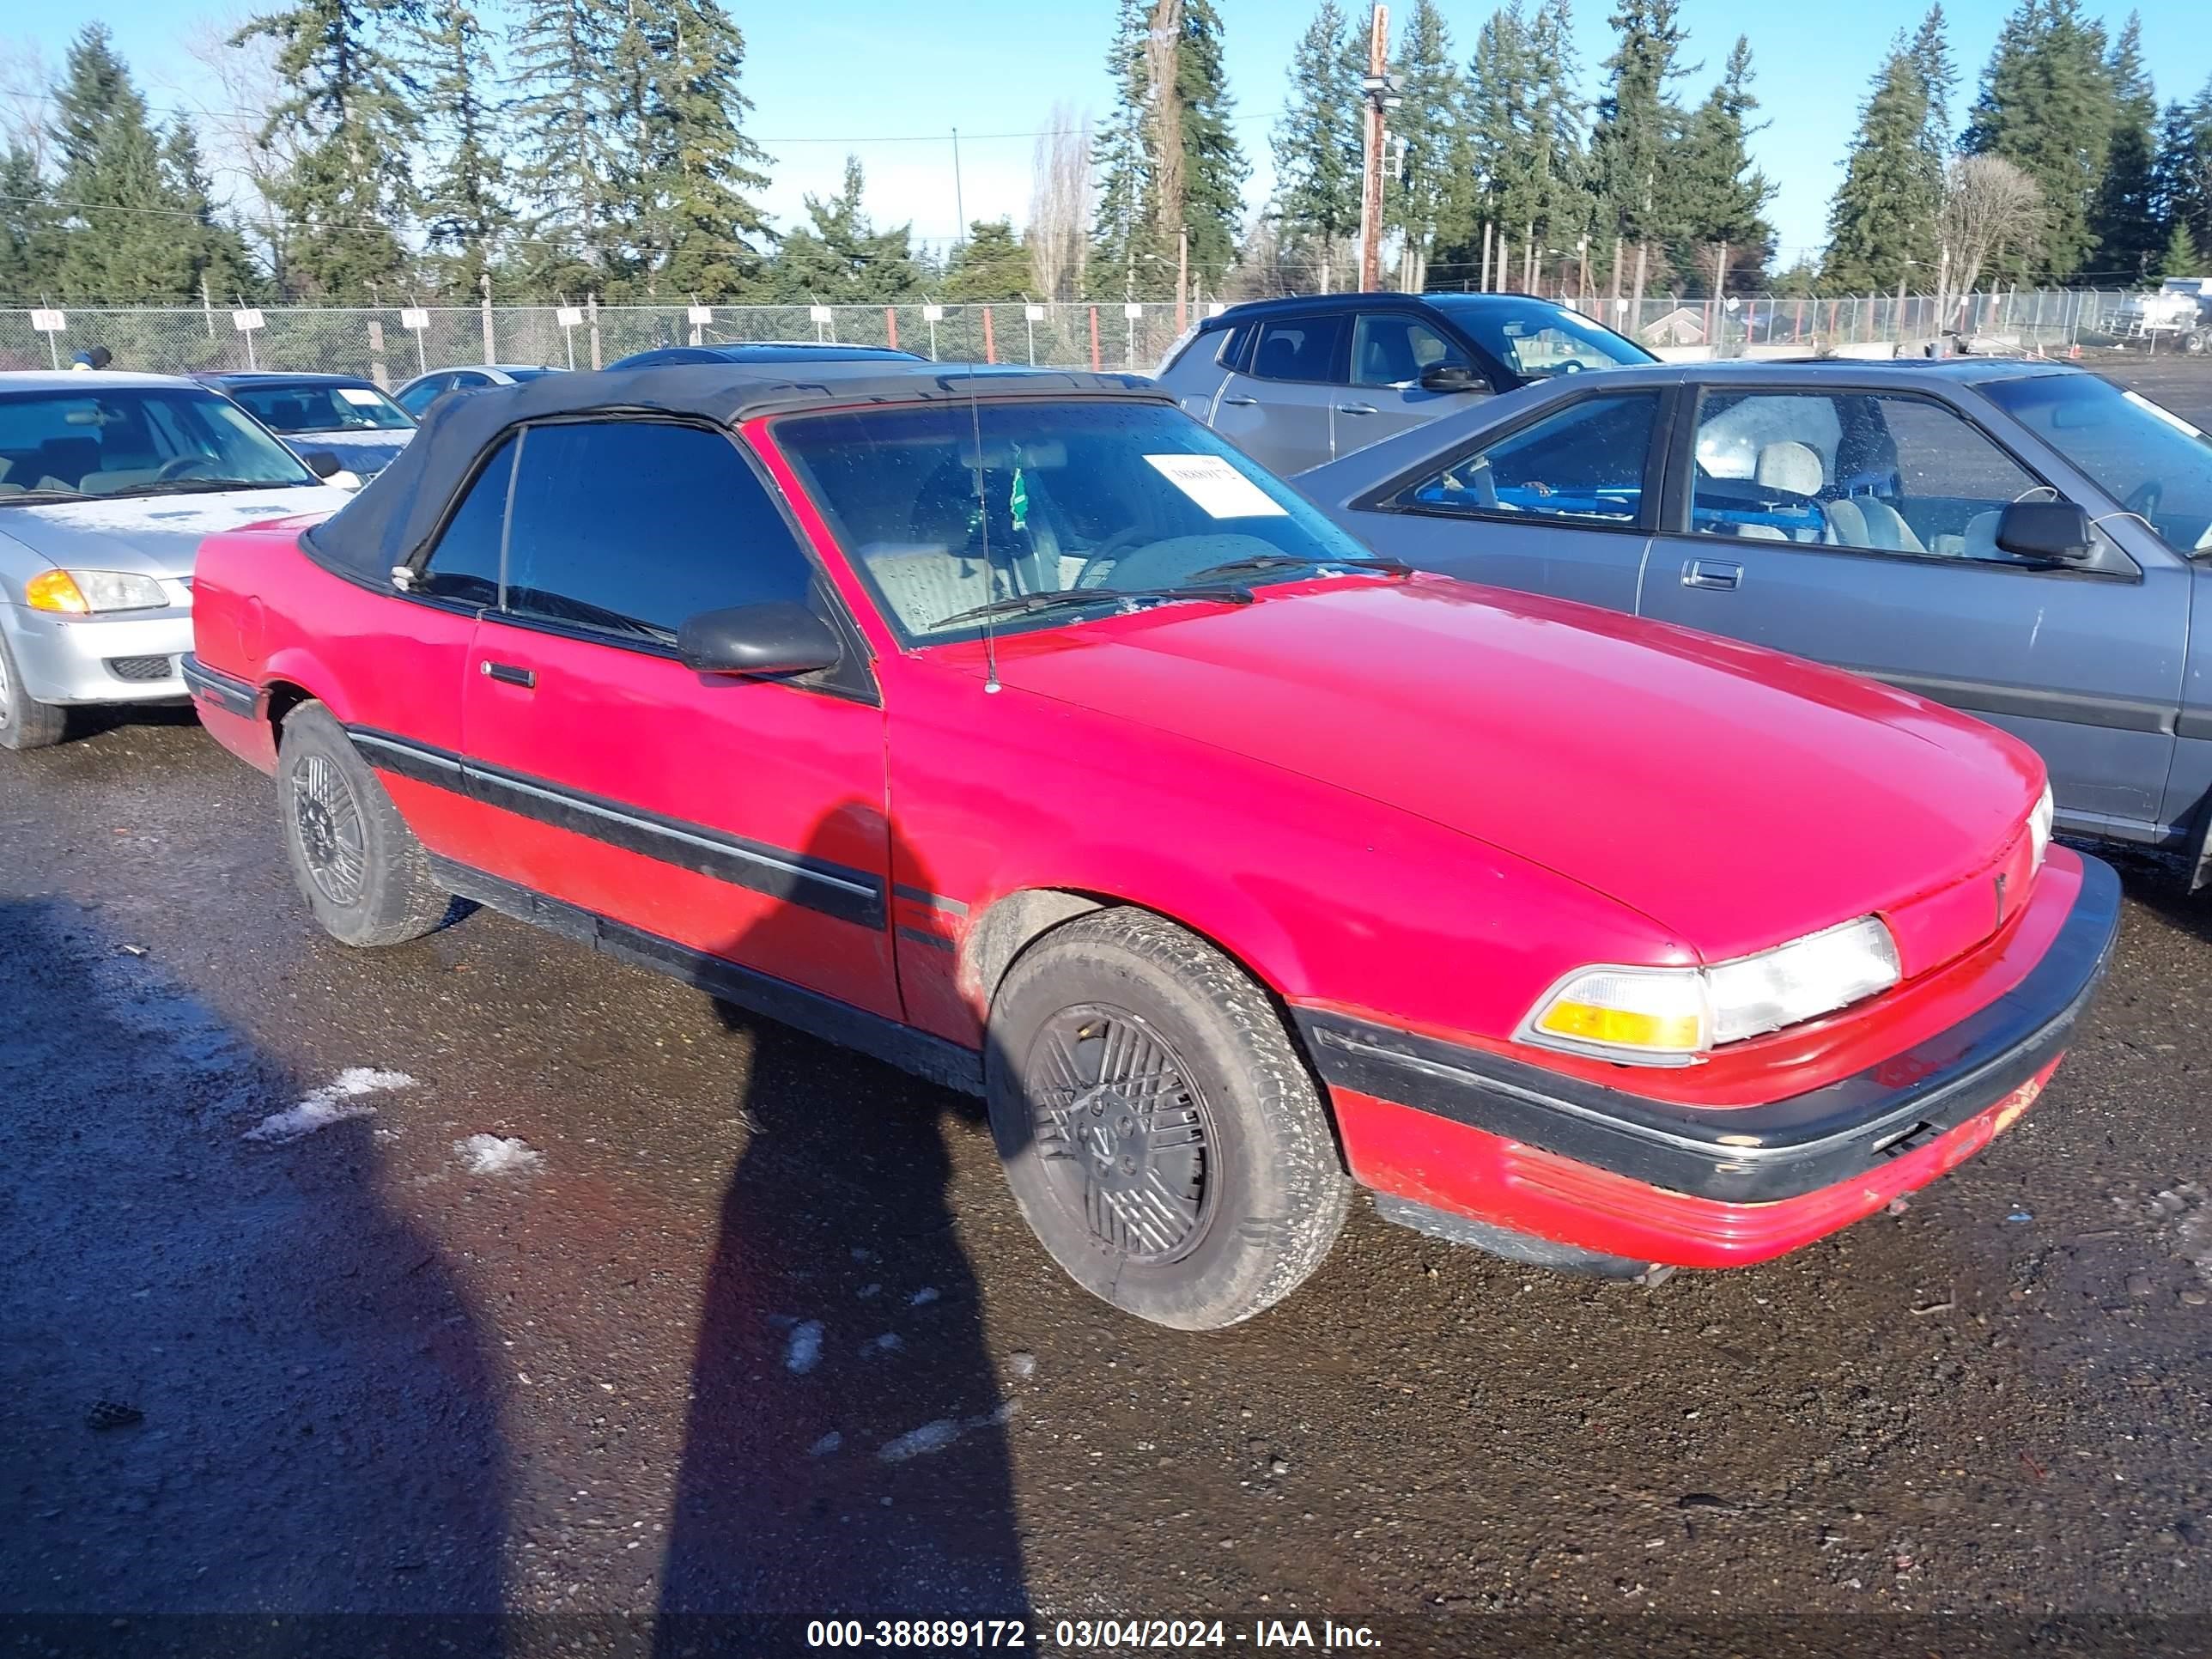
top-left (1000, 577), bottom-right (2044, 960)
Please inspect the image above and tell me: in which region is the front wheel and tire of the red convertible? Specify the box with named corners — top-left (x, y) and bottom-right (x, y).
top-left (987, 909), bottom-right (1352, 1332)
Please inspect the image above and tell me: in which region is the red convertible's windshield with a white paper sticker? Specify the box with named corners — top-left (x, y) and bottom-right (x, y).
top-left (776, 400), bottom-right (1371, 641)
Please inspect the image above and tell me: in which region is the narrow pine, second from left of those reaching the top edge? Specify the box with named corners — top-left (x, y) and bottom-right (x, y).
top-left (414, 0), bottom-right (515, 303)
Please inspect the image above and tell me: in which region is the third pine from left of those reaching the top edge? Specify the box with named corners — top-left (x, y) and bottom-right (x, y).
top-left (507, 0), bottom-right (622, 295)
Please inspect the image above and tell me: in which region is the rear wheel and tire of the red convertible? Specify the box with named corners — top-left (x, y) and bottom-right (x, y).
top-left (276, 703), bottom-right (453, 949)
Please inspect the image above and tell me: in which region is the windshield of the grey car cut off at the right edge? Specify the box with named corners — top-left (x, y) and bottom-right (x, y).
top-left (1982, 374), bottom-right (2212, 553)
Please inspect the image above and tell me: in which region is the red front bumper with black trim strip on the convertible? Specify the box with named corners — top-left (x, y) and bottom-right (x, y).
top-left (1297, 858), bottom-right (2119, 1267)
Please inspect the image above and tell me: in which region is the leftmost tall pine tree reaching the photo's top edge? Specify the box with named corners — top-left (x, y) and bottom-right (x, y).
top-left (234, 0), bottom-right (420, 301)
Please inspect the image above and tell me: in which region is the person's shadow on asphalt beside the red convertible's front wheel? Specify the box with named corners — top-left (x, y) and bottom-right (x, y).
top-left (657, 807), bottom-right (1029, 1655)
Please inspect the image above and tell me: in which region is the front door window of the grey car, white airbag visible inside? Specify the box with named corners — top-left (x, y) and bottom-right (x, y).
top-left (1690, 392), bottom-right (2037, 564)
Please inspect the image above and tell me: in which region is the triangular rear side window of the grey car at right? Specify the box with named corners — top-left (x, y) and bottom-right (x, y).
top-left (1398, 392), bottom-right (1659, 526)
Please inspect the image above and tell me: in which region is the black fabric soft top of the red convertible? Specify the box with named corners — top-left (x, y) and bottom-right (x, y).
top-left (305, 358), bottom-right (1172, 581)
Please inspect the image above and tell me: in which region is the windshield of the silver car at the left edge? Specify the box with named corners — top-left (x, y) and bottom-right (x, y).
top-left (0, 386), bottom-right (316, 507)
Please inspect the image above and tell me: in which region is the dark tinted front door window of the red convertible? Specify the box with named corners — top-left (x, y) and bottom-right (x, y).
top-left (507, 420), bottom-right (814, 644)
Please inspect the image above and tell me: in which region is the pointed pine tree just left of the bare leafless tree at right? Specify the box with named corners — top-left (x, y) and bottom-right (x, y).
top-left (1820, 45), bottom-right (1942, 295)
